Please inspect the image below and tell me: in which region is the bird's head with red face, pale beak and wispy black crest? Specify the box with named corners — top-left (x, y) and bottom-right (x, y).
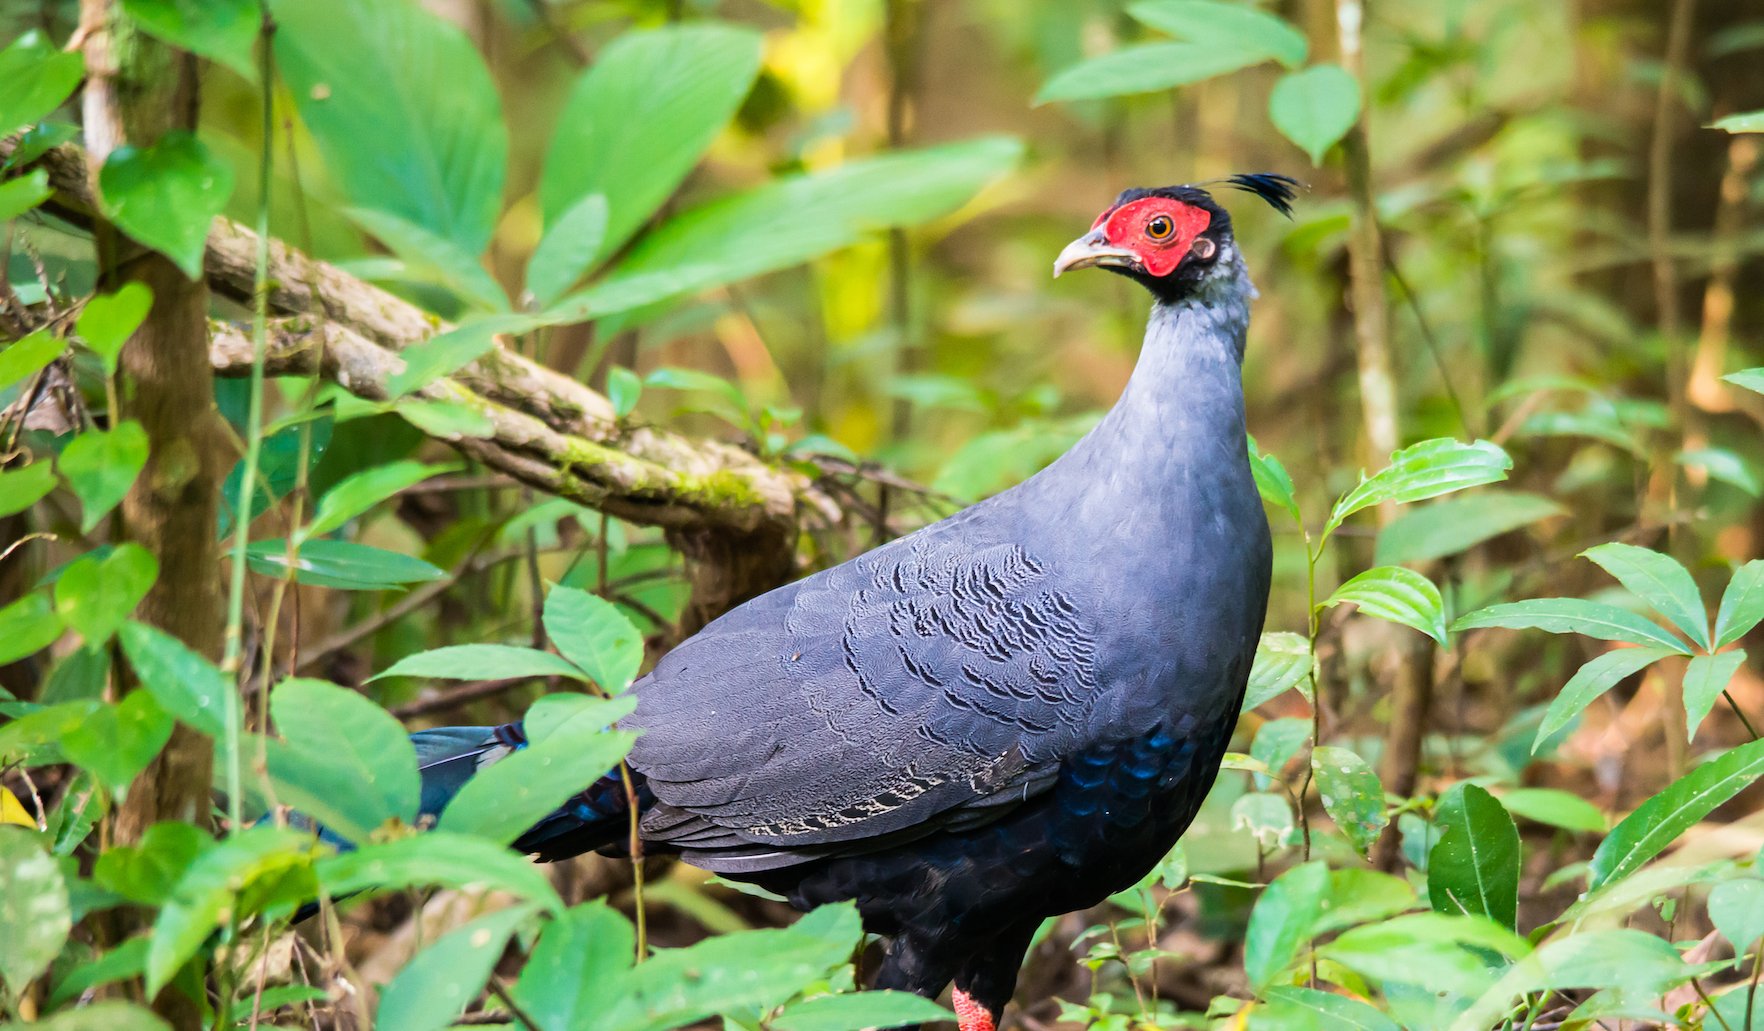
top-left (1053, 173), bottom-right (1298, 300)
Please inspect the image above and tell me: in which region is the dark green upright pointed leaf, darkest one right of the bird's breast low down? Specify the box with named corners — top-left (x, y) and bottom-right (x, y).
top-left (1427, 784), bottom-right (1521, 929)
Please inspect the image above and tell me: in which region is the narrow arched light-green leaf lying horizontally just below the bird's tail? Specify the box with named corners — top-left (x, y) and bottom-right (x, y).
top-left (318, 830), bottom-right (563, 913)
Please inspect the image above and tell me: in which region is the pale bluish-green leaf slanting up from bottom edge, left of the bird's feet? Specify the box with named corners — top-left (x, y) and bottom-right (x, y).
top-left (376, 906), bottom-right (533, 1031)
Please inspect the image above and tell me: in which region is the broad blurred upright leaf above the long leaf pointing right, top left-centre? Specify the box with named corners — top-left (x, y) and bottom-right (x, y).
top-left (534, 21), bottom-right (760, 252)
